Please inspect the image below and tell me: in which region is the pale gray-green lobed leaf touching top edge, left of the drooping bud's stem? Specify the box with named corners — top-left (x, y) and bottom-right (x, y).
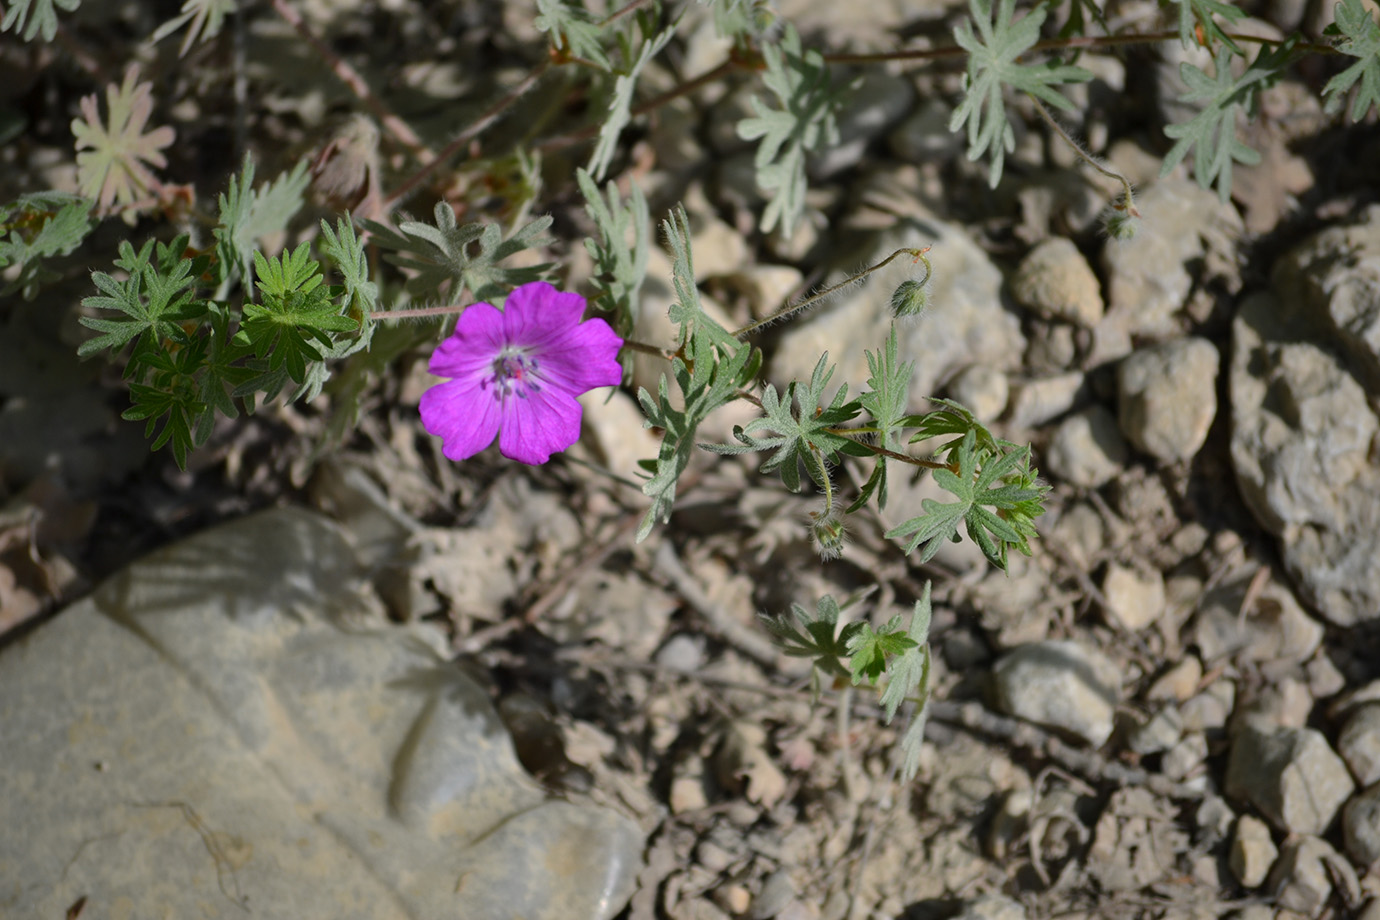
top-left (949, 0), bottom-right (1093, 189)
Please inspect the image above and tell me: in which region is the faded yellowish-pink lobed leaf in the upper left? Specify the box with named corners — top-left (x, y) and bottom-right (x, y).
top-left (72, 63), bottom-right (177, 219)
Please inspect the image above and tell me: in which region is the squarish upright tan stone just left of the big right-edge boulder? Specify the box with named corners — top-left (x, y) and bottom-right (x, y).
top-left (1116, 338), bottom-right (1220, 463)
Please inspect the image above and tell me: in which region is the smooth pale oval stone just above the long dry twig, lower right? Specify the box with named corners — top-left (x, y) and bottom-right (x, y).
top-left (994, 640), bottom-right (1121, 748)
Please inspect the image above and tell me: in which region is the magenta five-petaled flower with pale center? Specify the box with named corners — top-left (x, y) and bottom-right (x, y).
top-left (421, 281), bottom-right (622, 463)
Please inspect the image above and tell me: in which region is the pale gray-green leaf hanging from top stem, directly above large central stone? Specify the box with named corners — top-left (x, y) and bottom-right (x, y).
top-left (738, 25), bottom-right (842, 236)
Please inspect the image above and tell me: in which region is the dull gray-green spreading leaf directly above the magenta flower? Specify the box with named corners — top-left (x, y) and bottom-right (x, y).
top-left (364, 201), bottom-right (552, 301)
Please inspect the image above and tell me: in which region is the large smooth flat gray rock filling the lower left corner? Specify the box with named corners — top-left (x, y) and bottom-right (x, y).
top-left (0, 509), bottom-right (643, 920)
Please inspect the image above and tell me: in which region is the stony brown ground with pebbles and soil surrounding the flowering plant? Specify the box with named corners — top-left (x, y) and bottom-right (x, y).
top-left (0, 0), bottom-right (1380, 920)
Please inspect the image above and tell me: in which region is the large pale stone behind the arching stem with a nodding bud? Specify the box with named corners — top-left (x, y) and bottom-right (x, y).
top-left (767, 214), bottom-right (1025, 407)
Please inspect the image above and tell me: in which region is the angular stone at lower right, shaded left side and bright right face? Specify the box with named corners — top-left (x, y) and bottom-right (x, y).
top-left (1225, 724), bottom-right (1355, 834)
